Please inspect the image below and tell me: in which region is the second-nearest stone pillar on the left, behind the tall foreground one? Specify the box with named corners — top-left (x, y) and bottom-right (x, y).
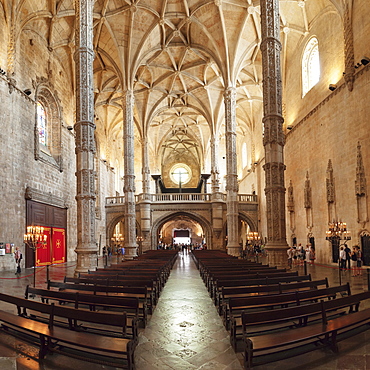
top-left (123, 90), bottom-right (137, 259)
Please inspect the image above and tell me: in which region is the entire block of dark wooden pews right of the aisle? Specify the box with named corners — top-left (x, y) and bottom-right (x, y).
top-left (193, 250), bottom-right (370, 369)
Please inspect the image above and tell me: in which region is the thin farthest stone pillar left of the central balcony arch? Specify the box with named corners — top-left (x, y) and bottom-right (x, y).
top-left (140, 137), bottom-right (152, 251)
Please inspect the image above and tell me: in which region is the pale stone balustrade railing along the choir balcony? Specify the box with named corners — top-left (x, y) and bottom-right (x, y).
top-left (105, 193), bottom-right (257, 206)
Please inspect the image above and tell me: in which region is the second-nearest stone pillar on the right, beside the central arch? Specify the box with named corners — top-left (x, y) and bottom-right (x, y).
top-left (224, 87), bottom-right (241, 256)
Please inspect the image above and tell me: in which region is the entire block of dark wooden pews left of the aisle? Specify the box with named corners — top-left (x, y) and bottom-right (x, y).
top-left (0, 250), bottom-right (177, 369)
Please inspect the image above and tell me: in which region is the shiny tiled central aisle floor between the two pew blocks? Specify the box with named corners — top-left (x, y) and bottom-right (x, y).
top-left (136, 254), bottom-right (242, 370)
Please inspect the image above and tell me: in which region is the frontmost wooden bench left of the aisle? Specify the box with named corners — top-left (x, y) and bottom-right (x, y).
top-left (0, 294), bottom-right (136, 369)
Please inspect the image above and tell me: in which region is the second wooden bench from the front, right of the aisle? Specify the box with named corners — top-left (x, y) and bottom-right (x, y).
top-left (224, 283), bottom-right (351, 348)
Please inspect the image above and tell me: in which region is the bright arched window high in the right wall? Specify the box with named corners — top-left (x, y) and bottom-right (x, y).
top-left (302, 37), bottom-right (320, 98)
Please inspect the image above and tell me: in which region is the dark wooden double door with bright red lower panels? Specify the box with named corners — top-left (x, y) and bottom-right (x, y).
top-left (25, 200), bottom-right (67, 267)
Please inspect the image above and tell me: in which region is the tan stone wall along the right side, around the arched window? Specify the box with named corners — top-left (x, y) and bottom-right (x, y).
top-left (284, 2), bottom-right (370, 263)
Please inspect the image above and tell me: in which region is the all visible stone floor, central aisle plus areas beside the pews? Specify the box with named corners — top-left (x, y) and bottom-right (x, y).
top-left (0, 254), bottom-right (370, 370)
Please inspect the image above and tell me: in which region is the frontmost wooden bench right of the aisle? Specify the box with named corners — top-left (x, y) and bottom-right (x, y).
top-left (242, 291), bottom-right (370, 369)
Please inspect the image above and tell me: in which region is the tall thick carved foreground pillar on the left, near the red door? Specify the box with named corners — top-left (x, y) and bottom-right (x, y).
top-left (74, 0), bottom-right (98, 275)
